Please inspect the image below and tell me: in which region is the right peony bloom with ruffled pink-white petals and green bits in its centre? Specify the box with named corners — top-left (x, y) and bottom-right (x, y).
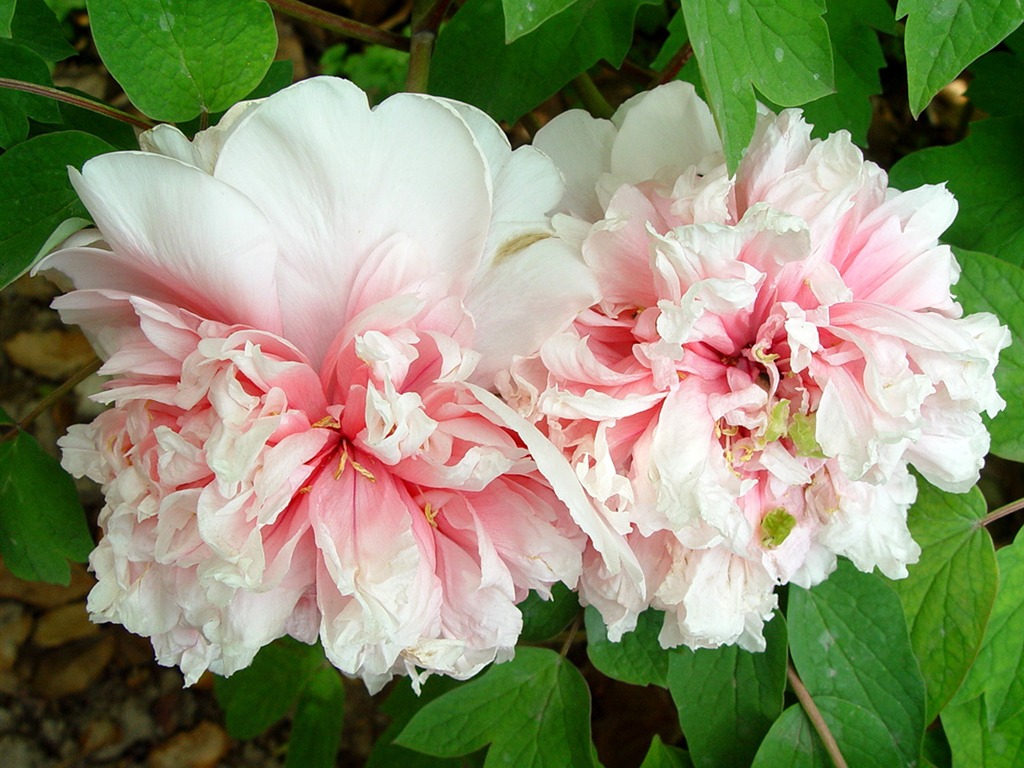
top-left (512, 83), bottom-right (1009, 649)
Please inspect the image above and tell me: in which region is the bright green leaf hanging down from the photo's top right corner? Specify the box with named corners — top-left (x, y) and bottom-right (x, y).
top-left (896, 0), bottom-right (1024, 117)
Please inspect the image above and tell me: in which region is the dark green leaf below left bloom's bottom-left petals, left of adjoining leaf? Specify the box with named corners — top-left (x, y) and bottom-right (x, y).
top-left (214, 640), bottom-right (324, 738)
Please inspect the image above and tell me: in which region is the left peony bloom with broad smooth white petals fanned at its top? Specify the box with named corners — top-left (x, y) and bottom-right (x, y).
top-left (40, 79), bottom-right (635, 690)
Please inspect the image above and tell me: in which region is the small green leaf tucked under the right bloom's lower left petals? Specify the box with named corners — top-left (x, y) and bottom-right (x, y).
top-left (585, 606), bottom-right (669, 688)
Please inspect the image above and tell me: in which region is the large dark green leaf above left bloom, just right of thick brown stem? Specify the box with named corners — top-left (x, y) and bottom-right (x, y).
top-left (430, 0), bottom-right (656, 122)
